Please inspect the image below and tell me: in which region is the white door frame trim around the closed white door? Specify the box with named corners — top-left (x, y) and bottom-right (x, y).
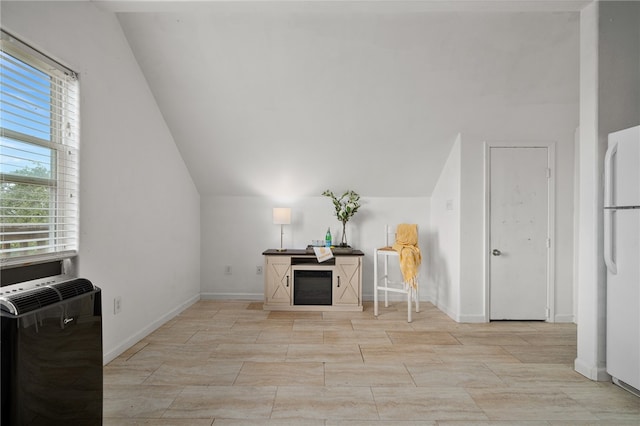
top-left (483, 141), bottom-right (556, 322)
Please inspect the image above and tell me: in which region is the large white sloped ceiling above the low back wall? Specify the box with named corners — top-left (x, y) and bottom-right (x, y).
top-left (106, 1), bottom-right (579, 196)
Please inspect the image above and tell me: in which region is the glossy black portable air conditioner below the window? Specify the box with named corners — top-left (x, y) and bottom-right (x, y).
top-left (0, 276), bottom-right (102, 426)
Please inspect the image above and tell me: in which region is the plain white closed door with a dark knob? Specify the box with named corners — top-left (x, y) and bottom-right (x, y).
top-left (488, 147), bottom-right (550, 320)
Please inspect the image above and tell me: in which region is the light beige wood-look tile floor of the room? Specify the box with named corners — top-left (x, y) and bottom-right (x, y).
top-left (104, 300), bottom-right (640, 426)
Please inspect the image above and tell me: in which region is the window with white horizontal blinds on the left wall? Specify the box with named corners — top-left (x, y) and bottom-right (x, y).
top-left (0, 31), bottom-right (79, 267)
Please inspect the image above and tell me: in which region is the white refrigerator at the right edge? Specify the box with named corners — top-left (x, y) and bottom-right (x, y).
top-left (604, 126), bottom-right (640, 393)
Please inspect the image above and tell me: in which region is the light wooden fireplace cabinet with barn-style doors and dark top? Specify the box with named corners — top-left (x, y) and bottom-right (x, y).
top-left (263, 249), bottom-right (364, 311)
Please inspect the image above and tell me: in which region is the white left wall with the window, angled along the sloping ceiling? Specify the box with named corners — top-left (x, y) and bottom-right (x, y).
top-left (2, 2), bottom-right (200, 362)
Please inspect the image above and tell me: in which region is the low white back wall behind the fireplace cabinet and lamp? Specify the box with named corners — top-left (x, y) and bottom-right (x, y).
top-left (201, 195), bottom-right (431, 300)
